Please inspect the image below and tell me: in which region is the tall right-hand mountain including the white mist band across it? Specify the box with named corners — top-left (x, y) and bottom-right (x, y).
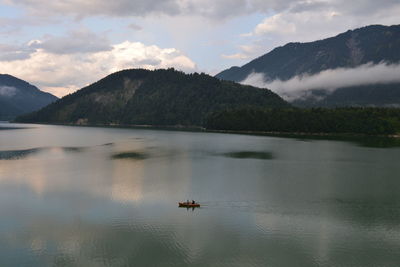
top-left (216, 25), bottom-right (400, 106)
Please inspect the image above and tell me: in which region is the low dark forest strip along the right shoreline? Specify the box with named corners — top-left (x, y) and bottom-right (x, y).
top-left (205, 107), bottom-right (400, 135)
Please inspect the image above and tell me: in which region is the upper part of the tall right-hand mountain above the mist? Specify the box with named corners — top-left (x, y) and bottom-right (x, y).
top-left (216, 25), bottom-right (400, 82)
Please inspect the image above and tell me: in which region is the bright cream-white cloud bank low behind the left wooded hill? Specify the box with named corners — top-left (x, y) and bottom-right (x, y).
top-left (0, 41), bottom-right (196, 96)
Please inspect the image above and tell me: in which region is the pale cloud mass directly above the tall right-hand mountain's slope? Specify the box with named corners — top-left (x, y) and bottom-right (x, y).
top-left (231, 0), bottom-right (400, 59)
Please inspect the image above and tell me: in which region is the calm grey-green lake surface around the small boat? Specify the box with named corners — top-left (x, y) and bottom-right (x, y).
top-left (0, 123), bottom-right (400, 267)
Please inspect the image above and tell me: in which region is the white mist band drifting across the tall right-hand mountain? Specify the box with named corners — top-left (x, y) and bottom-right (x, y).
top-left (241, 63), bottom-right (400, 101)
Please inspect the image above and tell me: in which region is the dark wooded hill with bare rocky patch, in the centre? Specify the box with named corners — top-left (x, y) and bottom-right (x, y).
top-left (17, 69), bottom-right (289, 126)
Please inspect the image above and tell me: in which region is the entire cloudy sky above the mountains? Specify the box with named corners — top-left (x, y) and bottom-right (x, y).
top-left (0, 0), bottom-right (400, 97)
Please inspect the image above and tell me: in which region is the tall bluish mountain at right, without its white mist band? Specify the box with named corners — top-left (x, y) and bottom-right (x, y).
top-left (216, 25), bottom-right (400, 106)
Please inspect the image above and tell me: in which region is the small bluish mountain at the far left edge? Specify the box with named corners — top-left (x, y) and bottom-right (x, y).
top-left (0, 74), bottom-right (57, 120)
